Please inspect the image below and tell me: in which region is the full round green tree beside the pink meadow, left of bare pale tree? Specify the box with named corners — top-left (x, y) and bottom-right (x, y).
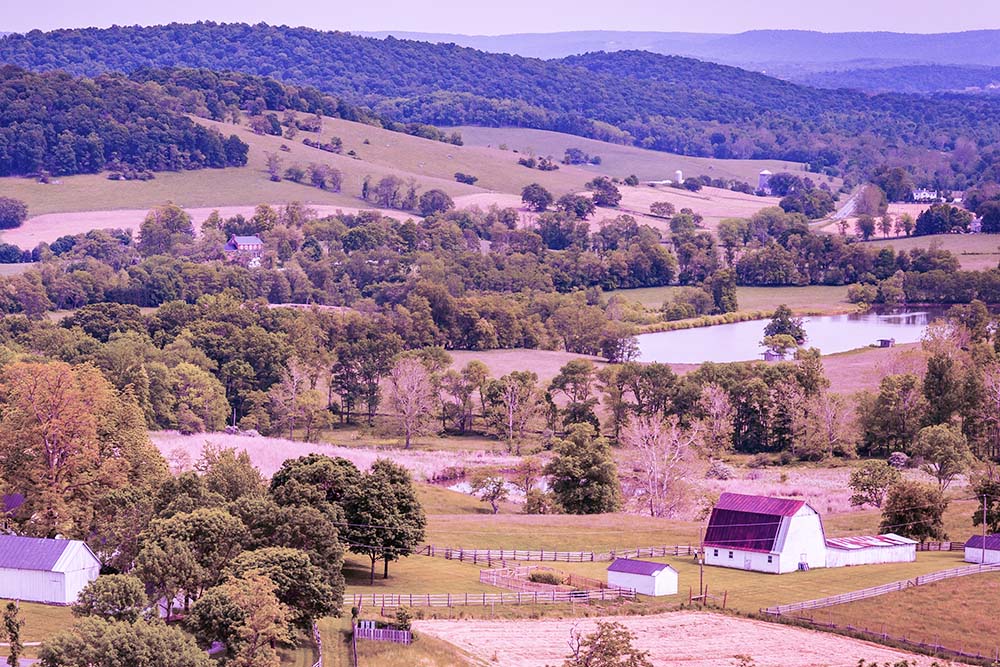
top-left (545, 424), bottom-right (621, 514)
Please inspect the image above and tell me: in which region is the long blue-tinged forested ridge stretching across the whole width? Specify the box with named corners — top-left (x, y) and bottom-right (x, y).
top-left (0, 23), bottom-right (1000, 188)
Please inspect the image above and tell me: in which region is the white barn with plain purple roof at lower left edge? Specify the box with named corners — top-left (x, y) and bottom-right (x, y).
top-left (0, 535), bottom-right (101, 605)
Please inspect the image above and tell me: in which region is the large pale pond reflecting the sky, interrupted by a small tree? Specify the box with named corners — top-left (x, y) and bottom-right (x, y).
top-left (638, 309), bottom-right (938, 364)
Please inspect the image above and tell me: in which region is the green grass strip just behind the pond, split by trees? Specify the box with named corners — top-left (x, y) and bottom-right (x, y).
top-left (607, 285), bottom-right (856, 315)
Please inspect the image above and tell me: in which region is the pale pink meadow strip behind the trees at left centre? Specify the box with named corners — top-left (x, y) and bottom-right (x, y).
top-left (150, 431), bottom-right (515, 480)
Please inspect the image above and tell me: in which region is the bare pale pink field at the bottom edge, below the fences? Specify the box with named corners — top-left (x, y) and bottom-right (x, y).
top-left (413, 612), bottom-right (948, 667)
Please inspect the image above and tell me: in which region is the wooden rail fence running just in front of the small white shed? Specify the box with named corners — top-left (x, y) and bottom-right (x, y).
top-left (352, 588), bottom-right (635, 609)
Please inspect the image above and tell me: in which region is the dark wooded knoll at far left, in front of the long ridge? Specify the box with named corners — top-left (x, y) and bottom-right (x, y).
top-left (0, 65), bottom-right (249, 176)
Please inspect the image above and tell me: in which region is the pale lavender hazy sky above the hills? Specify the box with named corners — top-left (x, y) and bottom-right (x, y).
top-left (0, 0), bottom-right (1000, 35)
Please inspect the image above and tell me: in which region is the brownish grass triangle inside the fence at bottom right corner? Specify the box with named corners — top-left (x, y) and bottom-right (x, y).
top-left (803, 573), bottom-right (1000, 656)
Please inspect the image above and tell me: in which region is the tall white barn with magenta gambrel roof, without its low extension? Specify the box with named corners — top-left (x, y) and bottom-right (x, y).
top-left (704, 493), bottom-right (826, 574)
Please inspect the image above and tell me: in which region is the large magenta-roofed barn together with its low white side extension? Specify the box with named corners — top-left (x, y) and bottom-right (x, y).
top-left (704, 493), bottom-right (917, 574)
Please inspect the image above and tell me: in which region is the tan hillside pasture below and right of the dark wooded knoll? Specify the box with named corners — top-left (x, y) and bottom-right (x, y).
top-left (0, 113), bottom-right (593, 219)
